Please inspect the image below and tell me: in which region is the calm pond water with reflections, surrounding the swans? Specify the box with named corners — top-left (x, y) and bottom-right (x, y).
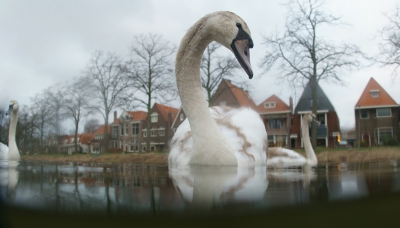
top-left (0, 161), bottom-right (400, 215)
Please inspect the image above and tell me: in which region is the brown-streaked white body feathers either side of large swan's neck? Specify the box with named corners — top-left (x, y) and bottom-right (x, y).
top-left (168, 107), bottom-right (268, 166)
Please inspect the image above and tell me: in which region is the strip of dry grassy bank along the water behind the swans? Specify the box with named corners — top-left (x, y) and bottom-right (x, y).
top-left (21, 147), bottom-right (400, 164)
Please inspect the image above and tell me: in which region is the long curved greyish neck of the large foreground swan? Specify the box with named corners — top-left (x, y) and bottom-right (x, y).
top-left (175, 20), bottom-right (237, 165)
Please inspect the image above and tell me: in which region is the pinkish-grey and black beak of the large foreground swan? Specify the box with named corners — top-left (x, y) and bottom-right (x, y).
top-left (232, 40), bottom-right (253, 79)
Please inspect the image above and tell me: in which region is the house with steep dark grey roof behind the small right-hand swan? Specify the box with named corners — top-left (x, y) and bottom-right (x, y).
top-left (290, 83), bottom-right (340, 148)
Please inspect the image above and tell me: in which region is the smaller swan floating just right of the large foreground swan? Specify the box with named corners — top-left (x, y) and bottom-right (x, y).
top-left (267, 112), bottom-right (319, 168)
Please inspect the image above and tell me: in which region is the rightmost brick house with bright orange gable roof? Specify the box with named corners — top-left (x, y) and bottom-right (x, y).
top-left (354, 78), bottom-right (400, 146)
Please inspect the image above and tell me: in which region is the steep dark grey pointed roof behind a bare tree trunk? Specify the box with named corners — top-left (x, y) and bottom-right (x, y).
top-left (294, 82), bottom-right (335, 113)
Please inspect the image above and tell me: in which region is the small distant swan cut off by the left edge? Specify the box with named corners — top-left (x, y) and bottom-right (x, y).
top-left (0, 100), bottom-right (20, 161)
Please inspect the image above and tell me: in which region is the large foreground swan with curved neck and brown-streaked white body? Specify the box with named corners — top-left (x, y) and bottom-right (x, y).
top-left (168, 11), bottom-right (268, 167)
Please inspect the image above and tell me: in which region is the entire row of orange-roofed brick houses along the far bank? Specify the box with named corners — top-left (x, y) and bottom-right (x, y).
top-left (60, 78), bottom-right (399, 153)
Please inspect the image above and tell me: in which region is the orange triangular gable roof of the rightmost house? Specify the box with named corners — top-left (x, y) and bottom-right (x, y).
top-left (355, 77), bottom-right (399, 109)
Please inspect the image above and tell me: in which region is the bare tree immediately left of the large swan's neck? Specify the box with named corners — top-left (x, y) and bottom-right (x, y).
top-left (125, 34), bottom-right (177, 151)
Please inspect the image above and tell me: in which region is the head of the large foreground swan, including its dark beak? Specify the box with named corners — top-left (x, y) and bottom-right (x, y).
top-left (206, 11), bottom-right (254, 79)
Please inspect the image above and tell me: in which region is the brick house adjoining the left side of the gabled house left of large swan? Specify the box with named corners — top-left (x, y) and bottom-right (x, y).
top-left (109, 111), bottom-right (147, 152)
